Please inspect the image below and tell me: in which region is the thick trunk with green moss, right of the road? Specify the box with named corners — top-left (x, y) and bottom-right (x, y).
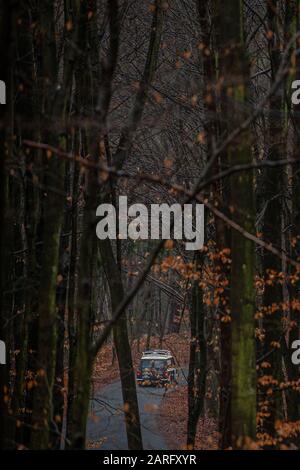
top-left (219, 1), bottom-right (256, 448)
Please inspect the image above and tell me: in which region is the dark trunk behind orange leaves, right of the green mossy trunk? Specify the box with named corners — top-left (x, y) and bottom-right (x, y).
top-left (262, 0), bottom-right (285, 436)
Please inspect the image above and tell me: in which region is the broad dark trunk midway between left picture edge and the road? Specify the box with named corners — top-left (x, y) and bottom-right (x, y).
top-left (30, 1), bottom-right (65, 449)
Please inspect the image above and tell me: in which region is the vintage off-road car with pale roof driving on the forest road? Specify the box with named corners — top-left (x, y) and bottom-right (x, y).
top-left (136, 349), bottom-right (178, 386)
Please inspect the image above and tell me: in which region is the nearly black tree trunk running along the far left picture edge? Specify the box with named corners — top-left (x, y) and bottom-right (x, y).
top-left (0, 1), bottom-right (20, 449)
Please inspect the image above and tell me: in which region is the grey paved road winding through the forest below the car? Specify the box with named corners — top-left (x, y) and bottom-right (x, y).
top-left (87, 373), bottom-right (184, 450)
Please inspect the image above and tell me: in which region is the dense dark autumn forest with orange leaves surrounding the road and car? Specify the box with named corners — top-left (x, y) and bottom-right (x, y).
top-left (0, 0), bottom-right (300, 449)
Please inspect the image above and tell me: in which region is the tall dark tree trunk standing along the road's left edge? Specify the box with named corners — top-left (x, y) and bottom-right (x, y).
top-left (68, 0), bottom-right (123, 448)
